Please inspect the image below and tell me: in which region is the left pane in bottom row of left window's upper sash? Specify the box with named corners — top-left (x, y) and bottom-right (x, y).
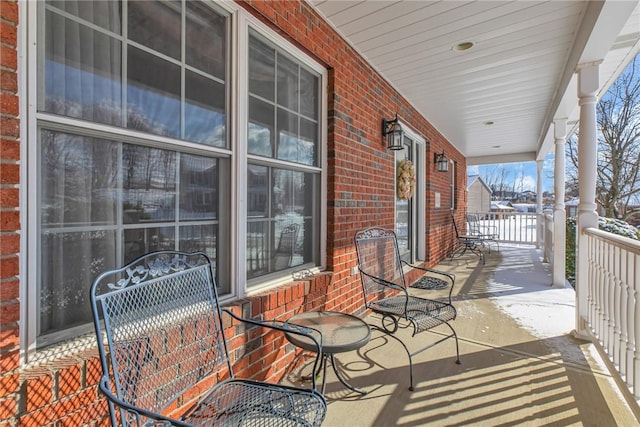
top-left (39, 12), bottom-right (122, 126)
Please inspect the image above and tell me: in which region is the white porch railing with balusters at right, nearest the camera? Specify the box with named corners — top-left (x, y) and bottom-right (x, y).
top-left (578, 228), bottom-right (640, 399)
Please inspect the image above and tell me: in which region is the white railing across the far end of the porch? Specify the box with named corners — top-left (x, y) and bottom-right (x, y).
top-left (469, 212), bottom-right (538, 245)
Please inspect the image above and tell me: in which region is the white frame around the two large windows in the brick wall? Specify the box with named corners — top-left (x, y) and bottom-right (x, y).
top-left (18, 1), bottom-right (327, 364)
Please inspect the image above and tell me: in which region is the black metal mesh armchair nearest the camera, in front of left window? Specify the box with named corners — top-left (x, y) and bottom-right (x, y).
top-left (91, 251), bottom-right (327, 427)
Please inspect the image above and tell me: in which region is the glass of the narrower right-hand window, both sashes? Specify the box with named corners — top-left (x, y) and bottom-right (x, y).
top-left (247, 34), bottom-right (320, 285)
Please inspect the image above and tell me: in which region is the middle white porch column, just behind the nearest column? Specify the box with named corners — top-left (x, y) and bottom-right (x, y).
top-left (551, 119), bottom-right (567, 288)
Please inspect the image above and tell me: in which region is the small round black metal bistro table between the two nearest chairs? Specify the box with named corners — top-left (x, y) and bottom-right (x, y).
top-left (287, 311), bottom-right (371, 394)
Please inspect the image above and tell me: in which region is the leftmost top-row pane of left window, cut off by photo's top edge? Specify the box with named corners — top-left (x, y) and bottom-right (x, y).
top-left (47, 0), bottom-right (122, 34)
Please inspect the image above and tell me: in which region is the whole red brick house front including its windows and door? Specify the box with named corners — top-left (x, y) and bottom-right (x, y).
top-left (0, 0), bottom-right (466, 426)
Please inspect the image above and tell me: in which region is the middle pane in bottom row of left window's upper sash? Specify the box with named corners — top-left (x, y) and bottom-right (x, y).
top-left (127, 48), bottom-right (180, 137)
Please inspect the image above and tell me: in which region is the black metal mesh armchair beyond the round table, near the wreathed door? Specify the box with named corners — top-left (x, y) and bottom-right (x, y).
top-left (355, 227), bottom-right (460, 390)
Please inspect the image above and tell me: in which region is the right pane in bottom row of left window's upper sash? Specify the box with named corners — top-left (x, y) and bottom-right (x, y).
top-left (184, 71), bottom-right (227, 147)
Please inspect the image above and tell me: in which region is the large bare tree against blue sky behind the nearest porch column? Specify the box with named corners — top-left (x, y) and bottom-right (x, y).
top-left (567, 56), bottom-right (640, 219)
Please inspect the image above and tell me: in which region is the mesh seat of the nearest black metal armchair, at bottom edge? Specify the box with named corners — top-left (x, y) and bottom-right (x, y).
top-left (183, 379), bottom-right (326, 427)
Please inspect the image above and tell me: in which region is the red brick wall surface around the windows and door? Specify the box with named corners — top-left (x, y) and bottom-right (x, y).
top-left (0, 0), bottom-right (466, 427)
